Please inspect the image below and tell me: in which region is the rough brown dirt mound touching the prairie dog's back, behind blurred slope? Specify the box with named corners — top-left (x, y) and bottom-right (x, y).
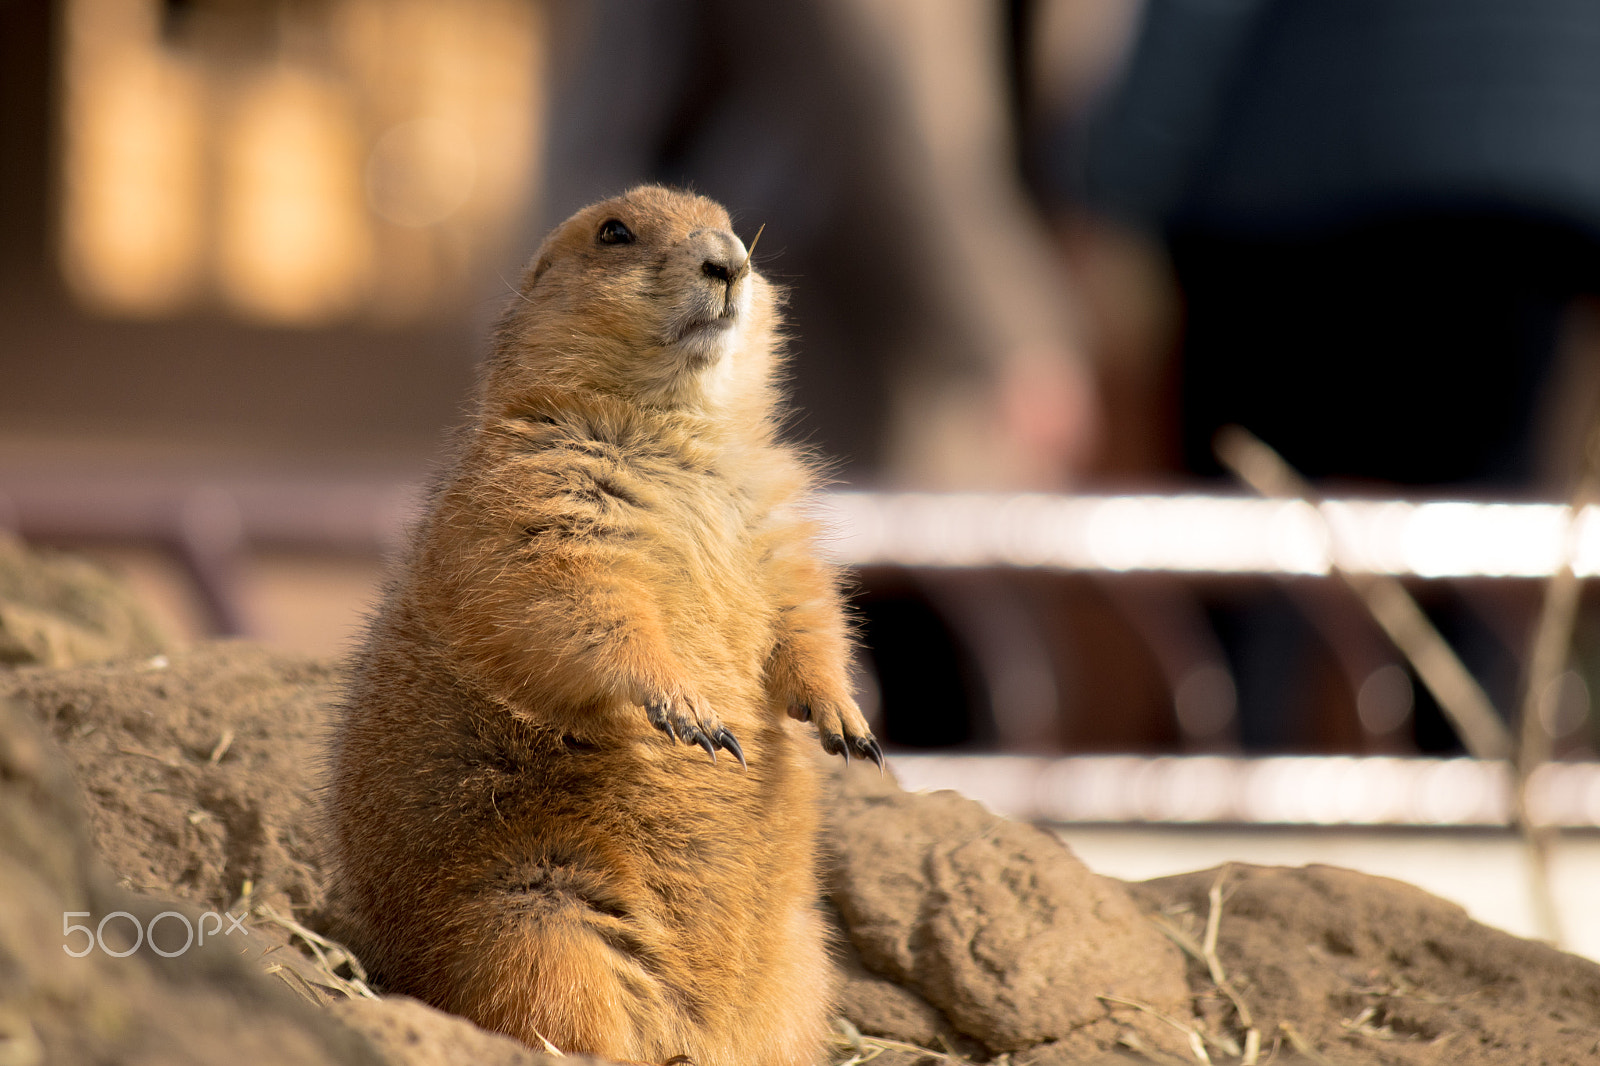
top-left (0, 643), bottom-right (336, 914)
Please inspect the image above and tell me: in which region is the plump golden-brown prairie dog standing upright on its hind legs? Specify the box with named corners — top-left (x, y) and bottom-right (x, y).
top-left (330, 187), bottom-right (882, 1066)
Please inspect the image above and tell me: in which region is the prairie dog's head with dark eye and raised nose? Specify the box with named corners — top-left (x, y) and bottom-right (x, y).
top-left (491, 186), bottom-right (776, 408)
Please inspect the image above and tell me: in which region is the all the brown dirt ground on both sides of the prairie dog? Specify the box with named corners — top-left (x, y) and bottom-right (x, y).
top-left (0, 534), bottom-right (1600, 1066)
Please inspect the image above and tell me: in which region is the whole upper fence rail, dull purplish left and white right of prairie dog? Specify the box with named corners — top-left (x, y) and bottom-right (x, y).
top-left (0, 480), bottom-right (1600, 578)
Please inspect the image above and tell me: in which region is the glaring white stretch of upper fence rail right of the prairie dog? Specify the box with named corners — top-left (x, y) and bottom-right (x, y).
top-left (826, 491), bottom-right (1600, 578)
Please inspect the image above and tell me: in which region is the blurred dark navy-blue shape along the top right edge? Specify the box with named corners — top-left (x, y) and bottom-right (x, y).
top-left (1086, 0), bottom-right (1600, 237)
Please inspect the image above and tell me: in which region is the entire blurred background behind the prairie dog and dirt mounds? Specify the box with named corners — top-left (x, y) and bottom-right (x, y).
top-left (9, 0), bottom-right (1600, 954)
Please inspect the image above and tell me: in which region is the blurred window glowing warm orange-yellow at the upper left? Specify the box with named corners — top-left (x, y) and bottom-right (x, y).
top-left (59, 0), bottom-right (544, 327)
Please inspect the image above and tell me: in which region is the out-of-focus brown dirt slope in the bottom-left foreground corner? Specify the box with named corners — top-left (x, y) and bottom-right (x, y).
top-left (0, 675), bottom-right (382, 1066)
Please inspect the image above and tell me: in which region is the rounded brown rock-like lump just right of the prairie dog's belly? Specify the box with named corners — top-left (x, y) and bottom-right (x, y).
top-left (830, 767), bottom-right (1190, 1052)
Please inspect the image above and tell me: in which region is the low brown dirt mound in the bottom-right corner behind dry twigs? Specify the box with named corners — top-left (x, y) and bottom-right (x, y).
top-left (1133, 864), bottom-right (1600, 1066)
